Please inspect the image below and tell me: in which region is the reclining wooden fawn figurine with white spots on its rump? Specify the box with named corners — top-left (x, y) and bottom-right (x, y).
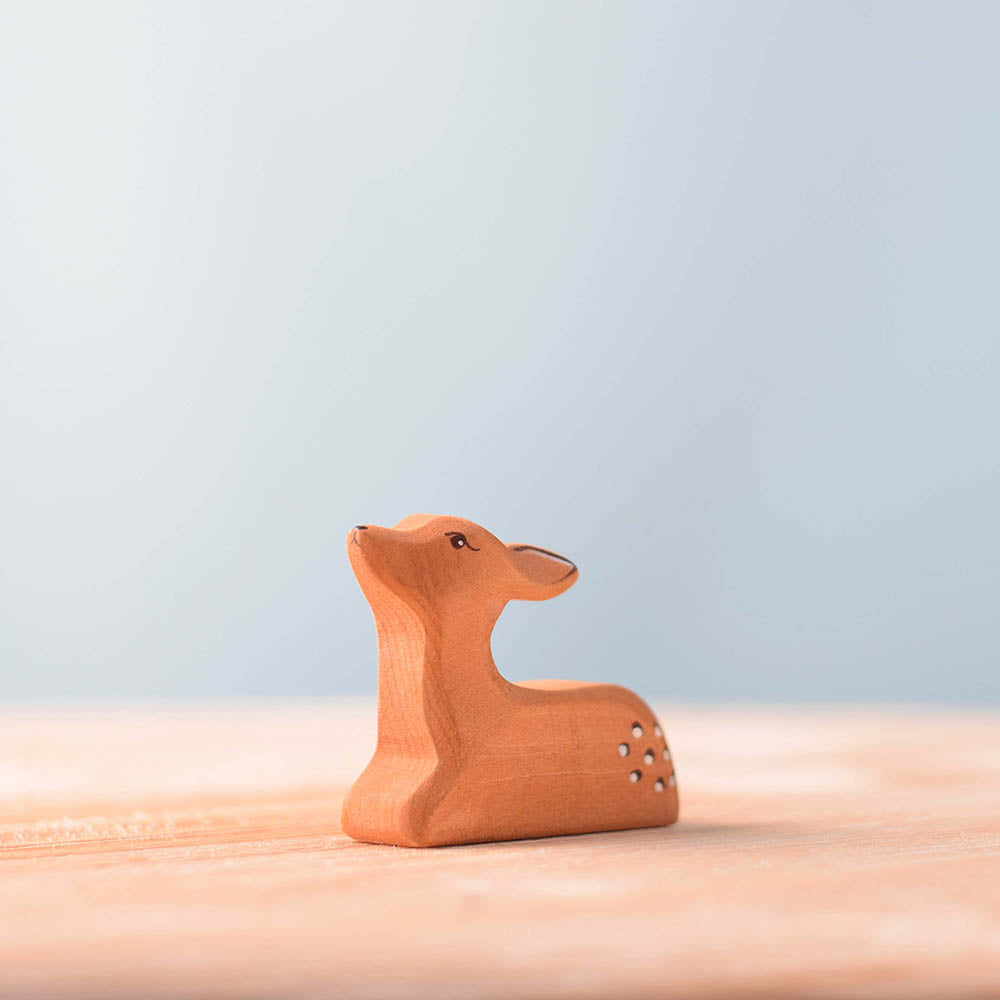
top-left (341, 514), bottom-right (677, 847)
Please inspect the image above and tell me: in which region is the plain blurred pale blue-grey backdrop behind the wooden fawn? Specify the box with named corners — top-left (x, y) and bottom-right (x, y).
top-left (0, 0), bottom-right (1000, 704)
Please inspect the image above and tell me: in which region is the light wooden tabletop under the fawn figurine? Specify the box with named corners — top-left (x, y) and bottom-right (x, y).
top-left (0, 701), bottom-right (1000, 1000)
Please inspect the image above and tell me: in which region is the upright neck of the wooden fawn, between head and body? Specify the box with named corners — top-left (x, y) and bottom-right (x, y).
top-left (375, 601), bottom-right (507, 753)
